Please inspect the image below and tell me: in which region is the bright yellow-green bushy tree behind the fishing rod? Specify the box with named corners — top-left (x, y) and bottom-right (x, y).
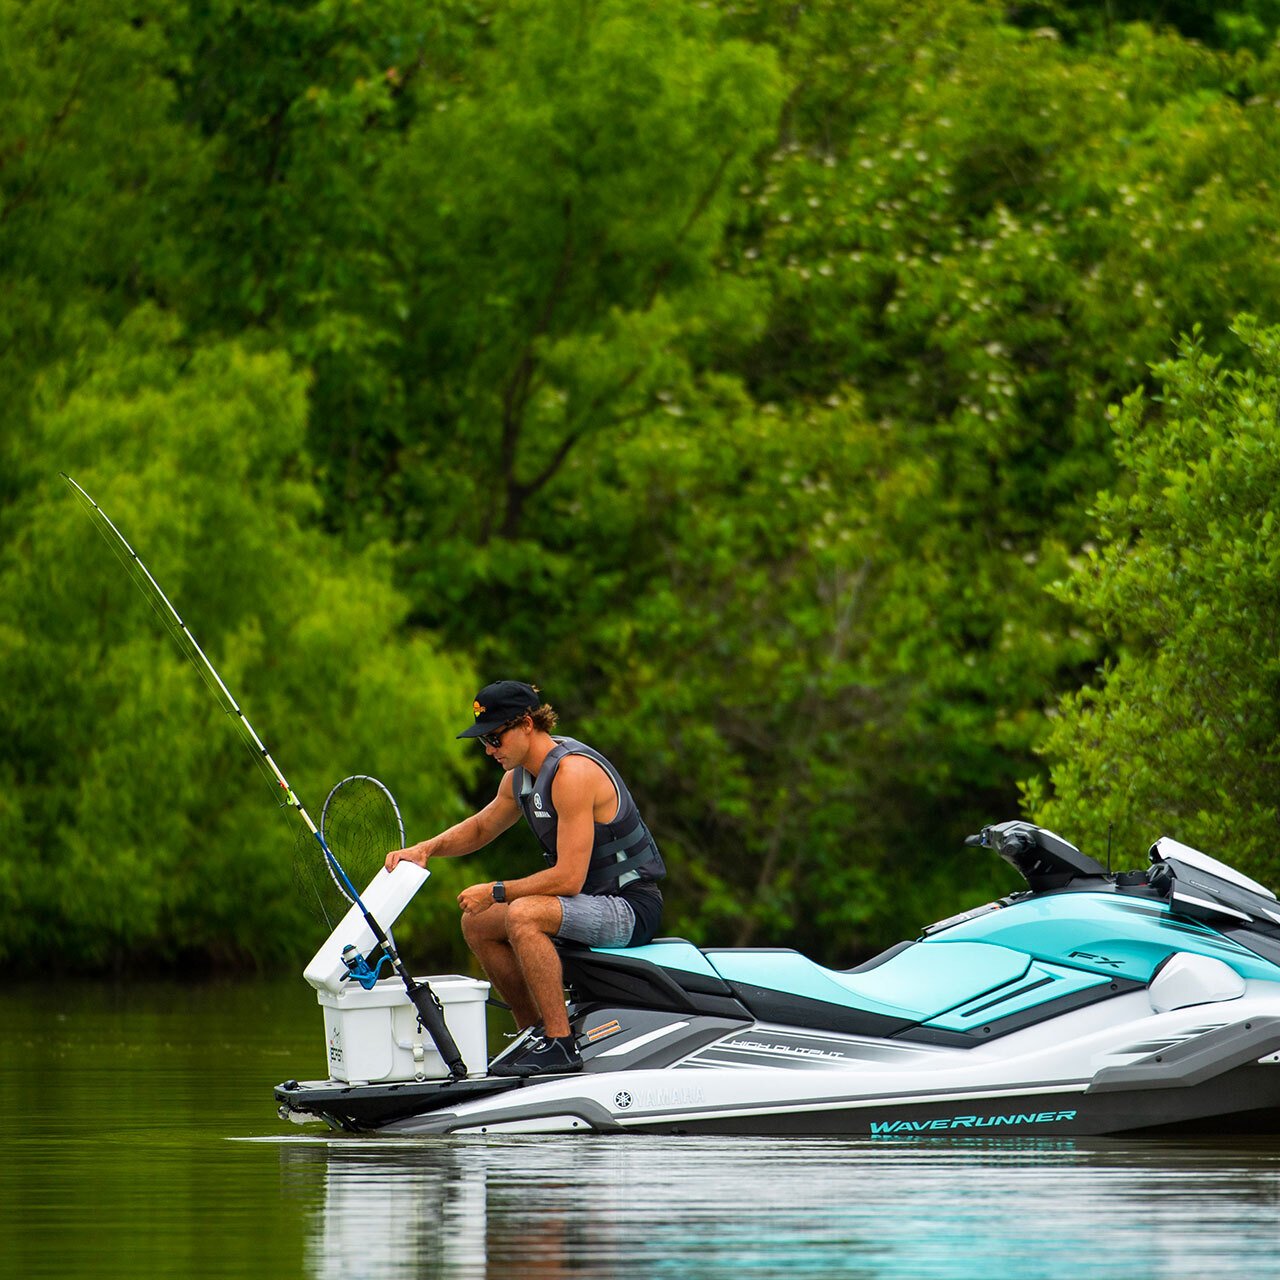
top-left (0, 308), bottom-right (474, 968)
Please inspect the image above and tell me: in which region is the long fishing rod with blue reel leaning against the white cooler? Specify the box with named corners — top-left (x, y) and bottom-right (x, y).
top-left (59, 471), bottom-right (467, 1080)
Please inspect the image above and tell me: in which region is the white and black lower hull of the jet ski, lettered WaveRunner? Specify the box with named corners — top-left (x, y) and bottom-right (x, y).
top-left (275, 984), bottom-right (1280, 1139)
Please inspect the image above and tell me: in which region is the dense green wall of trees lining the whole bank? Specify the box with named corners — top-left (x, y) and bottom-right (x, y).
top-left (0, 0), bottom-right (1280, 964)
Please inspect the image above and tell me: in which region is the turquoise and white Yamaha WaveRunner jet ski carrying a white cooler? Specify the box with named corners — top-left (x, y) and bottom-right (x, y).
top-left (275, 822), bottom-right (1280, 1138)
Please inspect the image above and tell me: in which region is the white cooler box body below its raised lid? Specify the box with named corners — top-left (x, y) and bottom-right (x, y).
top-left (316, 973), bottom-right (489, 1084)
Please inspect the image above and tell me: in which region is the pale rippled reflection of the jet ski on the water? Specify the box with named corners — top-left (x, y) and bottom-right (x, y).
top-left (280, 1137), bottom-right (1280, 1280)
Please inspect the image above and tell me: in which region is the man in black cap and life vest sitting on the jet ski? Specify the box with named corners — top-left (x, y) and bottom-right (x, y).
top-left (387, 680), bottom-right (667, 1075)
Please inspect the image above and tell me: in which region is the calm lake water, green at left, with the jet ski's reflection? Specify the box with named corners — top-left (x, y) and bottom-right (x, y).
top-left (0, 979), bottom-right (1280, 1280)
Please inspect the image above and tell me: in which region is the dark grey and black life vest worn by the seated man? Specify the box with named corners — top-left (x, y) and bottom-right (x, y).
top-left (511, 737), bottom-right (667, 893)
